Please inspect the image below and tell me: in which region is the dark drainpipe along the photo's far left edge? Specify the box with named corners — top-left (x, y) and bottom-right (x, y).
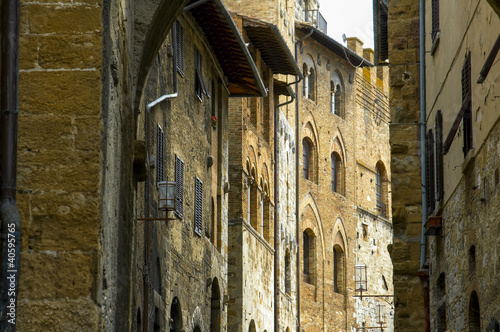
top-left (0, 0), bottom-right (21, 331)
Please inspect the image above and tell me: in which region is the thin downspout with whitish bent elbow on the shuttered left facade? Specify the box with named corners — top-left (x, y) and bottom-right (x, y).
top-left (142, 33), bottom-right (178, 332)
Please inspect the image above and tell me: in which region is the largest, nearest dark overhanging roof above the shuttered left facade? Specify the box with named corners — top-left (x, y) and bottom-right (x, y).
top-left (188, 0), bottom-right (267, 97)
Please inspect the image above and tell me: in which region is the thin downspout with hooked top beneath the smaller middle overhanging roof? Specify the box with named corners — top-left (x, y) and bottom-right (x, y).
top-left (274, 84), bottom-right (295, 332)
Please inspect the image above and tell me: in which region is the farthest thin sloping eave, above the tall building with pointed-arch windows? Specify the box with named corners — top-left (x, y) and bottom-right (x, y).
top-left (295, 22), bottom-right (373, 67)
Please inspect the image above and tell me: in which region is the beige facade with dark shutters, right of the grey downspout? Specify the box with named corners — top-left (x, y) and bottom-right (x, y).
top-left (425, 0), bottom-right (500, 331)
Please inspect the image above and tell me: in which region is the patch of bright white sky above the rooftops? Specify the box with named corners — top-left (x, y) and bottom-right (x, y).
top-left (319, 0), bottom-right (373, 49)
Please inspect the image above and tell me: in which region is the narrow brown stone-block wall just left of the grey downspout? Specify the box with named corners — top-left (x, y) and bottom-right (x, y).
top-left (388, 1), bottom-right (425, 331)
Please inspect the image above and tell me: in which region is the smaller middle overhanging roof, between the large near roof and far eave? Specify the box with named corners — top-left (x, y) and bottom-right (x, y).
top-left (240, 16), bottom-right (304, 79)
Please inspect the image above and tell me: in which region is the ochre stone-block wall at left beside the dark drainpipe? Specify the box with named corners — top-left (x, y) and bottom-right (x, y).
top-left (17, 1), bottom-right (103, 331)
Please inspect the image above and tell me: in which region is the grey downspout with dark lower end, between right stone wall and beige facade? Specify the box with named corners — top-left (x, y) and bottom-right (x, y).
top-left (418, 0), bottom-right (430, 332)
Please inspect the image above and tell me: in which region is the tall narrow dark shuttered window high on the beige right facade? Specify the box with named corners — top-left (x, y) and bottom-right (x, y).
top-left (462, 52), bottom-right (472, 157)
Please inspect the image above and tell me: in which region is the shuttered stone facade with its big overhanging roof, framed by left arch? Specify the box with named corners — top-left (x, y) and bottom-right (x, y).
top-left (133, 2), bottom-right (266, 331)
